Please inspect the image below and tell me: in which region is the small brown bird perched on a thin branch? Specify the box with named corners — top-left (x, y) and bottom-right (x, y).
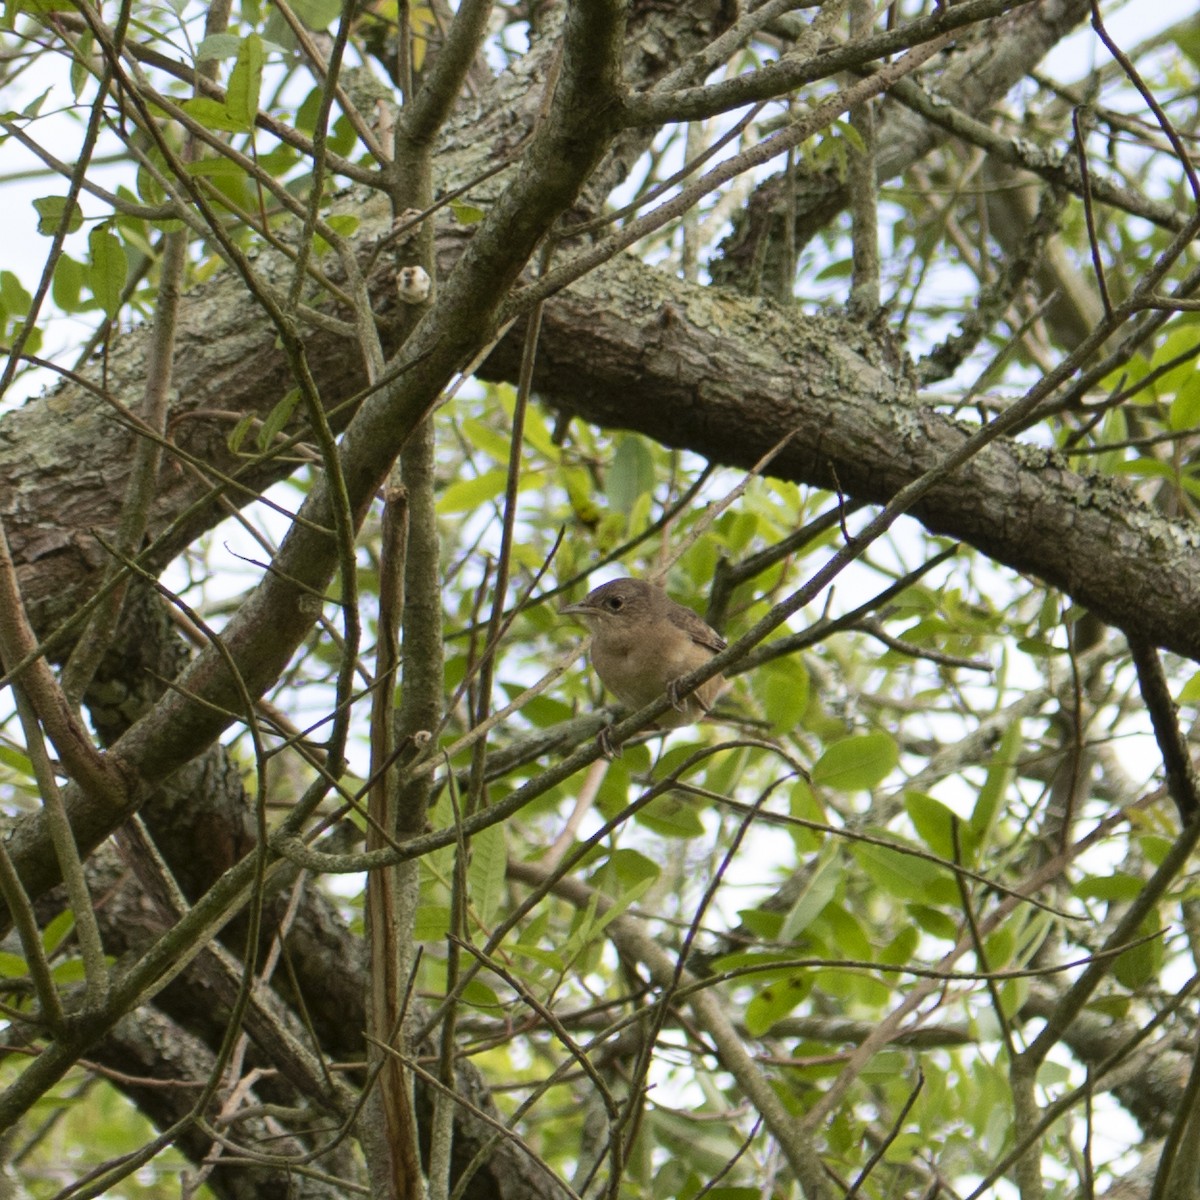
top-left (559, 578), bottom-right (725, 728)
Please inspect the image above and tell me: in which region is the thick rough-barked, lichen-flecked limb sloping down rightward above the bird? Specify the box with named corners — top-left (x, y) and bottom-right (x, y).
top-left (484, 260), bottom-right (1200, 658)
